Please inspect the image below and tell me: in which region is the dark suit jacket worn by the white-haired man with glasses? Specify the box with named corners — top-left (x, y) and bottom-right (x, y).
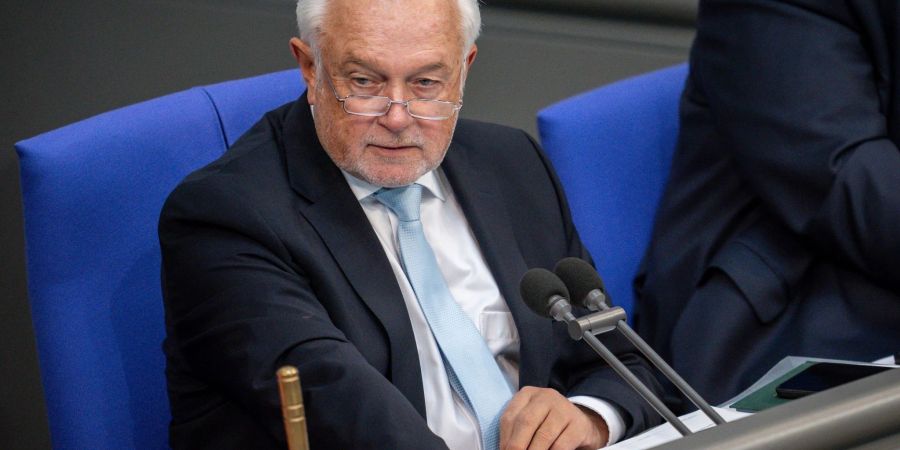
top-left (160, 96), bottom-right (659, 449)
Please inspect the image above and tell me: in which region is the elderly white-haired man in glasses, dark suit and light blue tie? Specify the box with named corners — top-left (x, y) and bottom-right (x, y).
top-left (160, 0), bottom-right (659, 450)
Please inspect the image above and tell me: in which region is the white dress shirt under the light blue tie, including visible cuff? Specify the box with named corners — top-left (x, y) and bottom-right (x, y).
top-left (344, 170), bottom-right (624, 450)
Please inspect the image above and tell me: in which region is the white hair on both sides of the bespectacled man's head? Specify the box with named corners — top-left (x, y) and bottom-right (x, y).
top-left (297, 0), bottom-right (481, 55)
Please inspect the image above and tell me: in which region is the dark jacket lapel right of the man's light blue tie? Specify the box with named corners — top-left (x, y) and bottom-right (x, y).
top-left (442, 136), bottom-right (552, 384)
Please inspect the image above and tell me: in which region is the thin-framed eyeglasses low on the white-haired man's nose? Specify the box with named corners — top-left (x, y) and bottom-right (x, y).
top-left (325, 76), bottom-right (462, 120)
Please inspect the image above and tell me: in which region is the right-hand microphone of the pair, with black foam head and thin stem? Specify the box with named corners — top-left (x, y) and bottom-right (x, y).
top-left (554, 258), bottom-right (725, 425)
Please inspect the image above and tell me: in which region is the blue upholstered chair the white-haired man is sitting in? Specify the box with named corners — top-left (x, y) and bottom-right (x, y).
top-left (16, 70), bottom-right (303, 449)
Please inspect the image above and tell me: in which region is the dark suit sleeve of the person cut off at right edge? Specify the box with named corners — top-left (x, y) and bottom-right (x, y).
top-left (691, 0), bottom-right (900, 288)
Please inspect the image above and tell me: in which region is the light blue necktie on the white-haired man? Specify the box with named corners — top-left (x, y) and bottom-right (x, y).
top-left (374, 184), bottom-right (512, 450)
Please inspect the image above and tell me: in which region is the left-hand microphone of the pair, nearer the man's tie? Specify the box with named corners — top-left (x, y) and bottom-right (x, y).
top-left (519, 268), bottom-right (691, 436)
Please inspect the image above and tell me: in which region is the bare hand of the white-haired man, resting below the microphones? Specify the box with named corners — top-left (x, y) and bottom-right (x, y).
top-left (500, 386), bottom-right (609, 450)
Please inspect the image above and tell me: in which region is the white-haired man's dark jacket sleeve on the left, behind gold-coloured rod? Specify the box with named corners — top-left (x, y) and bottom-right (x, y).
top-left (160, 181), bottom-right (445, 449)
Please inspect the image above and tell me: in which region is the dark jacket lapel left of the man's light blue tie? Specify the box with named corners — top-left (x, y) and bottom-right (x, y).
top-left (284, 95), bottom-right (425, 417)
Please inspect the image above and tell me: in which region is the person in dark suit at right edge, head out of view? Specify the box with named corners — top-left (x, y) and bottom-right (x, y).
top-left (635, 0), bottom-right (900, 412)
